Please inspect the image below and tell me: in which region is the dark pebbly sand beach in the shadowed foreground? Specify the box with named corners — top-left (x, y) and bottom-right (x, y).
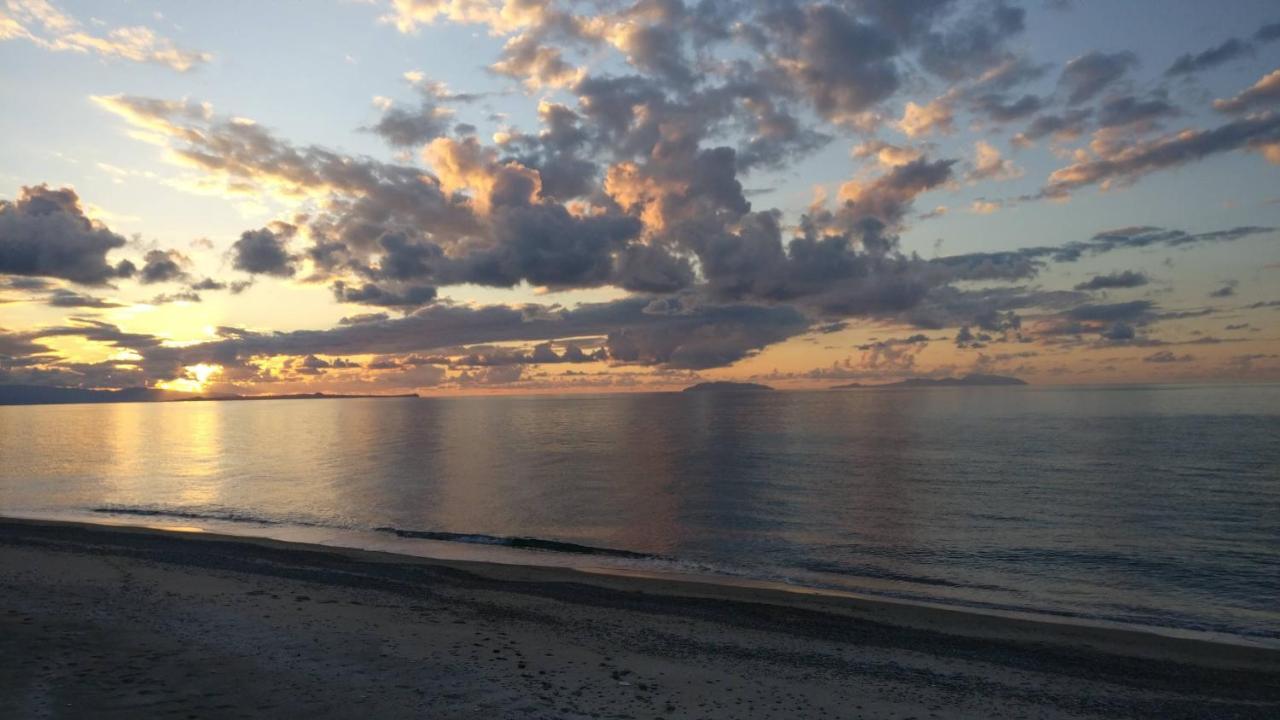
top-left (0, 520), bottom-right (1280, 720)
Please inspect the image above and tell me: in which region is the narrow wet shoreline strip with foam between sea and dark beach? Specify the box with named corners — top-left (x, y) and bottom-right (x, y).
top-left (0, 515), bottom-right (1280, 673)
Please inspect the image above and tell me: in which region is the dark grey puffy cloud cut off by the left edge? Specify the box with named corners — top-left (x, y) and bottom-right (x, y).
top-left (0, 184), bottom-right (134, 284)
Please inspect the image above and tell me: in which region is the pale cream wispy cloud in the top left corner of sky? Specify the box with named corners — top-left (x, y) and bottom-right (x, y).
top-left (0, 0), bottom-right (212, 73)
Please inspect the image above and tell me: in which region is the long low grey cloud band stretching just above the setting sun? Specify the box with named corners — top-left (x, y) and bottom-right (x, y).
top-left (0, 292), bottom-right (810, 386)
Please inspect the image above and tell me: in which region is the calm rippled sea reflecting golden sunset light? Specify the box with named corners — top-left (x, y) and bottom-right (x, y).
top-left (0, 386), bottom-right (1280, 644)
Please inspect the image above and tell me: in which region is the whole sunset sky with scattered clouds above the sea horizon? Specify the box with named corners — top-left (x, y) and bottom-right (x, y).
top-left (0, 0), bottom-right (1280, 395)
